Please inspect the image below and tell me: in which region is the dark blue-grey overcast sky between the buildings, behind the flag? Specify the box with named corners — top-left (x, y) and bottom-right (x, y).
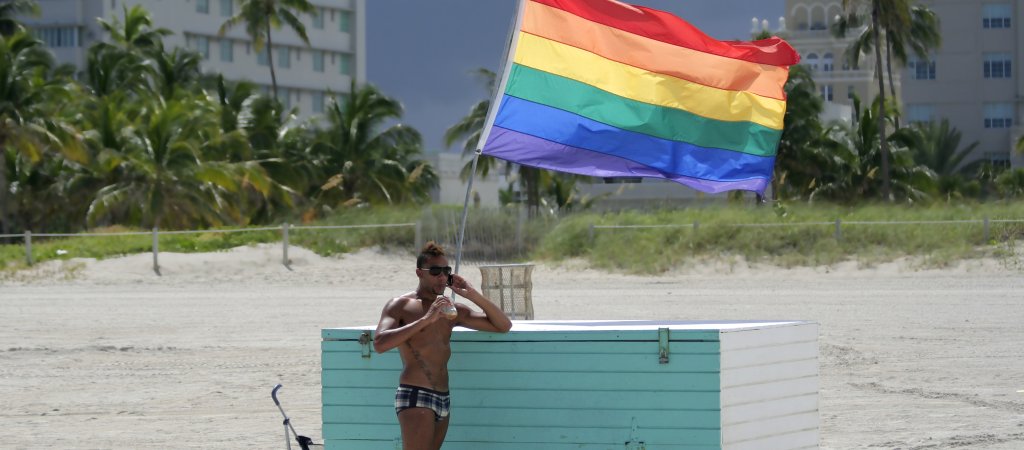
top-left (367, 0), bottom-right (785, 152)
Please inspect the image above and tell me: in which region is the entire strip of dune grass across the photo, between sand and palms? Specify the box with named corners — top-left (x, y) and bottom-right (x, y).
top-left (0, 202), bottom-right (1024, 274)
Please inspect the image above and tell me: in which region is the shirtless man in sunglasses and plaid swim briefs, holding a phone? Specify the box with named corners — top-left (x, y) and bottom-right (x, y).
top-left (374, 242), bottom-right (512, 450)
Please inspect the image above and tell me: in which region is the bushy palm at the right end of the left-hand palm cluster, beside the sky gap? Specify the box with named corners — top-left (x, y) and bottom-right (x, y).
top-left (310, 82), bottom-right (437, 207)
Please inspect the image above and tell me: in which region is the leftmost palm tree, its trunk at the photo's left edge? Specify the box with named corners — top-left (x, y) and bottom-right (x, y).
top-left (0, 32), bottom-right (87, 233)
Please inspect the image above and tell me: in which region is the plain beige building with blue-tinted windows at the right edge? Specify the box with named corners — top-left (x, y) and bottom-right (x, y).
top-left (902, 0), bottom-right (1024, 167)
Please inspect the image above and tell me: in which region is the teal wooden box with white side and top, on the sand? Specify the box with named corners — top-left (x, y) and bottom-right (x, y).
top-left (322, 321), bottom-right (818, 450)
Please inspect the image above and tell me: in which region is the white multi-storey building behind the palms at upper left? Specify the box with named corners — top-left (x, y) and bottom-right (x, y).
top-left (23, 0), bottom-right (367, 116)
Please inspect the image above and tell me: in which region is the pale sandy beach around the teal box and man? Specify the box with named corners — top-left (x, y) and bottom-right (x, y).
top-left (0, 245), bottom-right (1024, 450)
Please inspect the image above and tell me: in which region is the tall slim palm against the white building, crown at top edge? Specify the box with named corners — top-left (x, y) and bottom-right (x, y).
top-left (220, 0), bottom-right (316, 99)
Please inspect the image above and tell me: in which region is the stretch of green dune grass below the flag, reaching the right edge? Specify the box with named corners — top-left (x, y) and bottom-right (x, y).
top-left (535, 203), bottom-right (1024, 274)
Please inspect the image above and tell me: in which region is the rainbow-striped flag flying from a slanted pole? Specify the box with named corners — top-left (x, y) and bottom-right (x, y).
top-left (481, 0), bottom-right (800, 193)
